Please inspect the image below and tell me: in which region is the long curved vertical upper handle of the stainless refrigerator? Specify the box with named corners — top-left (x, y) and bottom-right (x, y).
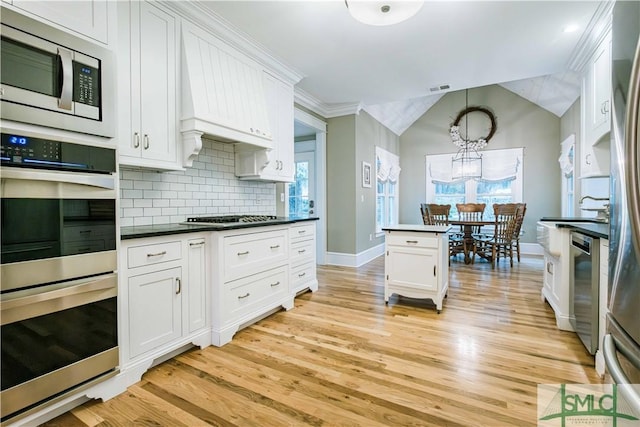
top-left (624, 35), bottom-right (640, 254)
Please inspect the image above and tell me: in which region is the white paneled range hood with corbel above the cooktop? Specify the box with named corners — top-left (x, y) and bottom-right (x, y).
top-left (180, 22), bottom-right (272, 166)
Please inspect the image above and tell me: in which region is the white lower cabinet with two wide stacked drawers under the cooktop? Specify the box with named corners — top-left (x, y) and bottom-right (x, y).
top-left (211, 225), bottom-right (294, 346)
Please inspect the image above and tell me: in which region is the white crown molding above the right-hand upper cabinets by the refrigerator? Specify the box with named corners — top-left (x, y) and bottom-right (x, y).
top-left (567, 0), bottom-right (615, 73)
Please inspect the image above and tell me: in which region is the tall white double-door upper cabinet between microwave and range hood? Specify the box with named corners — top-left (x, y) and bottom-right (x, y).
top-left (118, 1), bottom-right (182, 170)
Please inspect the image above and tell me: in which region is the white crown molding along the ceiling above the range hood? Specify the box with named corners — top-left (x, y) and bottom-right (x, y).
top-left (164, 0), bottom-right (304, 85)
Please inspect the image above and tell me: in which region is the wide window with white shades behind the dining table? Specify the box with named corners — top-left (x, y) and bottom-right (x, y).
top-left (426, 148), bottom-right (523, 221)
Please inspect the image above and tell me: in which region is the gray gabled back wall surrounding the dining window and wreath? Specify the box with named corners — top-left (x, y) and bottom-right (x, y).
top-left (400, 85), bottom-right (561, 242)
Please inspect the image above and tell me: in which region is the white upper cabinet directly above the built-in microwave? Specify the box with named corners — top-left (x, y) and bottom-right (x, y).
top-left (10, 0), bottom-right (109, 44)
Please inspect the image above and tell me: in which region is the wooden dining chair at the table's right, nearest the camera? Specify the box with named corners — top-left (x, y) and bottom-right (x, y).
top-left (471, 203), bottom-right (522, 269)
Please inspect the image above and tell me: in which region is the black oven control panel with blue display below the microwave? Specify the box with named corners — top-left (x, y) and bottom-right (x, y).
top-left (0, 133), bottom-right (116, 173)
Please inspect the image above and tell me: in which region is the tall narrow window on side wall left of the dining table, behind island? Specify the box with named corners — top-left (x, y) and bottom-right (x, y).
top-left (376, 147), bottom-right (400, 234)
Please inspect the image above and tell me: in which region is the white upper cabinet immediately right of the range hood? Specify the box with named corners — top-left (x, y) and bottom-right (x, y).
top-left (236, 71), bottom-right (294, 182)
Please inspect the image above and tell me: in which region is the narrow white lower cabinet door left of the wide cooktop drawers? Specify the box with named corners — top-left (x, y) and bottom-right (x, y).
top-left (185, 238), bottom-right (209, 333)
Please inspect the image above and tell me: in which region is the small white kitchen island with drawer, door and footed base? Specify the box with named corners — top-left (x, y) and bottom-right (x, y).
top-left (382, 224), bottom-right (451, 313)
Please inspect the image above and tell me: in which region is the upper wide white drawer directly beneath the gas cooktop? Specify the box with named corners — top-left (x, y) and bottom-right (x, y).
top-left (223, 230), bottom-right (289, 282)
